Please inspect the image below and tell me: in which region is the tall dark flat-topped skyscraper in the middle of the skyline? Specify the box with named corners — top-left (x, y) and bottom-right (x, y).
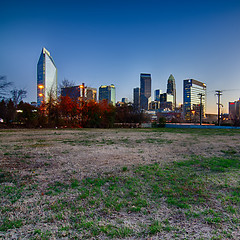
top-left (140, 73), bottom-right (151, 110)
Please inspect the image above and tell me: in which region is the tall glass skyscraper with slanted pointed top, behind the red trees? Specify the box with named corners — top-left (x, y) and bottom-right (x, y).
top-left (37, 48), bottom-right (57, 106)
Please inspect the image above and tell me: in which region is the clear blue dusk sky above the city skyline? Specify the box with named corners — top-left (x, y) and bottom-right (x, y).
top-left (0, 0), bottom-right (240, 113)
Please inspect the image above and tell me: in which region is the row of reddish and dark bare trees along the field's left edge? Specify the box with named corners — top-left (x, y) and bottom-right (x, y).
top-left (0, 77), bottom-right (147, 128)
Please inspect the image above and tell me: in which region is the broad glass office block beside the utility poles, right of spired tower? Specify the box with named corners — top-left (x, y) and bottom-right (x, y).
top-left (183, 79), bottom-right (206, 121)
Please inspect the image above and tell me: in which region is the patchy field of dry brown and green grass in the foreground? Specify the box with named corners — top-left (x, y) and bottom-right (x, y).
top-left (0, 129), bottom-right (240, 240)
